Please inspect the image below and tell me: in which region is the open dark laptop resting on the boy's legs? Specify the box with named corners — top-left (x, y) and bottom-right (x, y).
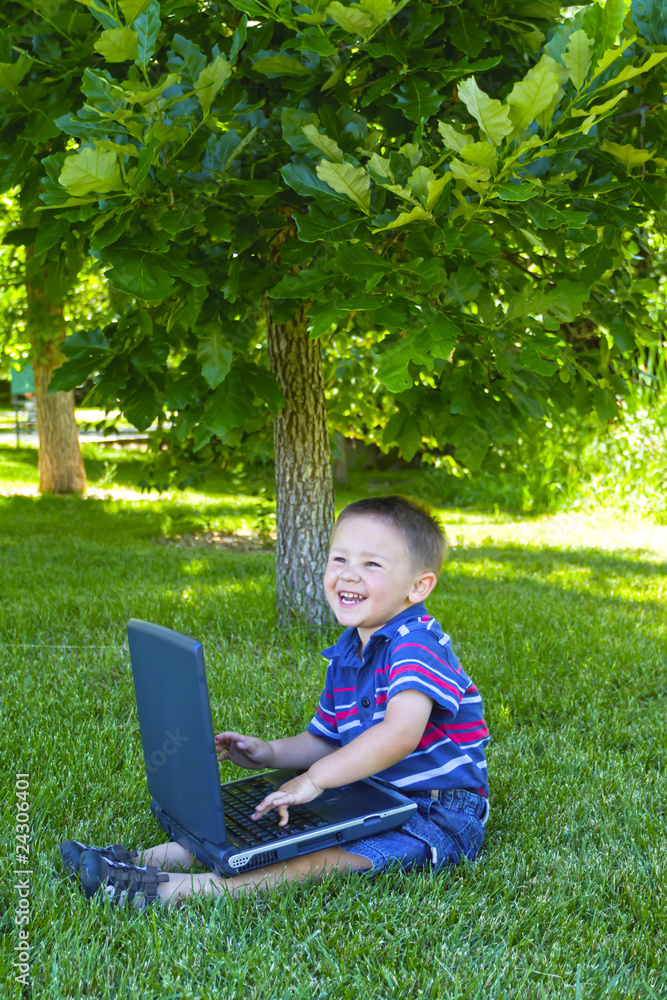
top-left (127, 618), bottom-right (417, 876)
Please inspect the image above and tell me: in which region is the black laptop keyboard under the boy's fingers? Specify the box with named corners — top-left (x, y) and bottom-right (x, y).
top-left (221, 777), bottom-right (329, 844)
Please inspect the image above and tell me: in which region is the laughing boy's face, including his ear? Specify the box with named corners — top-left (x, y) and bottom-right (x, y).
top-left (324, 514), bottom-right (436, 645)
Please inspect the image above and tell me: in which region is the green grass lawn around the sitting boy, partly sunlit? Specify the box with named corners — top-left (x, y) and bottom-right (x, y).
top-left (0, 449), bottom-right (667, 1000)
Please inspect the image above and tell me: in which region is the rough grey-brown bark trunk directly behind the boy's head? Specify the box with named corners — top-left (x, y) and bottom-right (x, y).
top-left (266, 306), bottom-right (334, 625)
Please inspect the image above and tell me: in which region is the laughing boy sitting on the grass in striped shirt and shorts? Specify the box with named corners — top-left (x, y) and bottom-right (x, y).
top-left (60, 496), bottom-right (489, 909)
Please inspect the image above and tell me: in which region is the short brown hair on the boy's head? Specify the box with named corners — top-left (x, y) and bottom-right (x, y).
top-left (332, 494), bottom-right (447, 576)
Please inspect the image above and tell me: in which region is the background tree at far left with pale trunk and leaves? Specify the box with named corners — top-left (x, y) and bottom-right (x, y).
top-left (0, 2), bottom-right (107, 493)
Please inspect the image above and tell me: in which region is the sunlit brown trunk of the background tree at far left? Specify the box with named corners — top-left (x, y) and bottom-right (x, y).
top-left (26, 266), bottom-right (86, 493)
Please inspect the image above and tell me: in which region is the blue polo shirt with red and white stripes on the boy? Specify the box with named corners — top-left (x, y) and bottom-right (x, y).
top-left (308, 604), bottom-right (489, 795)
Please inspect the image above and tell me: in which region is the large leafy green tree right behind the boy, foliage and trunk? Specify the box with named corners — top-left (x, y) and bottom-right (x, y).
top-left (2, 0), bottom-right (667, 617)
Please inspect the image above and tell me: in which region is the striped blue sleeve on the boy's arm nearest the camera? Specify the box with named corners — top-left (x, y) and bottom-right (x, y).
top-left (387, 629), bottom-right (471, 719)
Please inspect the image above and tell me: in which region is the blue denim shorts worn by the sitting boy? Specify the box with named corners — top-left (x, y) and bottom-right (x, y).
top-left (345, 788), bottom-right (489, 875)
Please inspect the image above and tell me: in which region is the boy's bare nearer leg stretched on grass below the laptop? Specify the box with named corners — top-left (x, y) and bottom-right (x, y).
top-left (155, 845), bottom-right (371, 904)
